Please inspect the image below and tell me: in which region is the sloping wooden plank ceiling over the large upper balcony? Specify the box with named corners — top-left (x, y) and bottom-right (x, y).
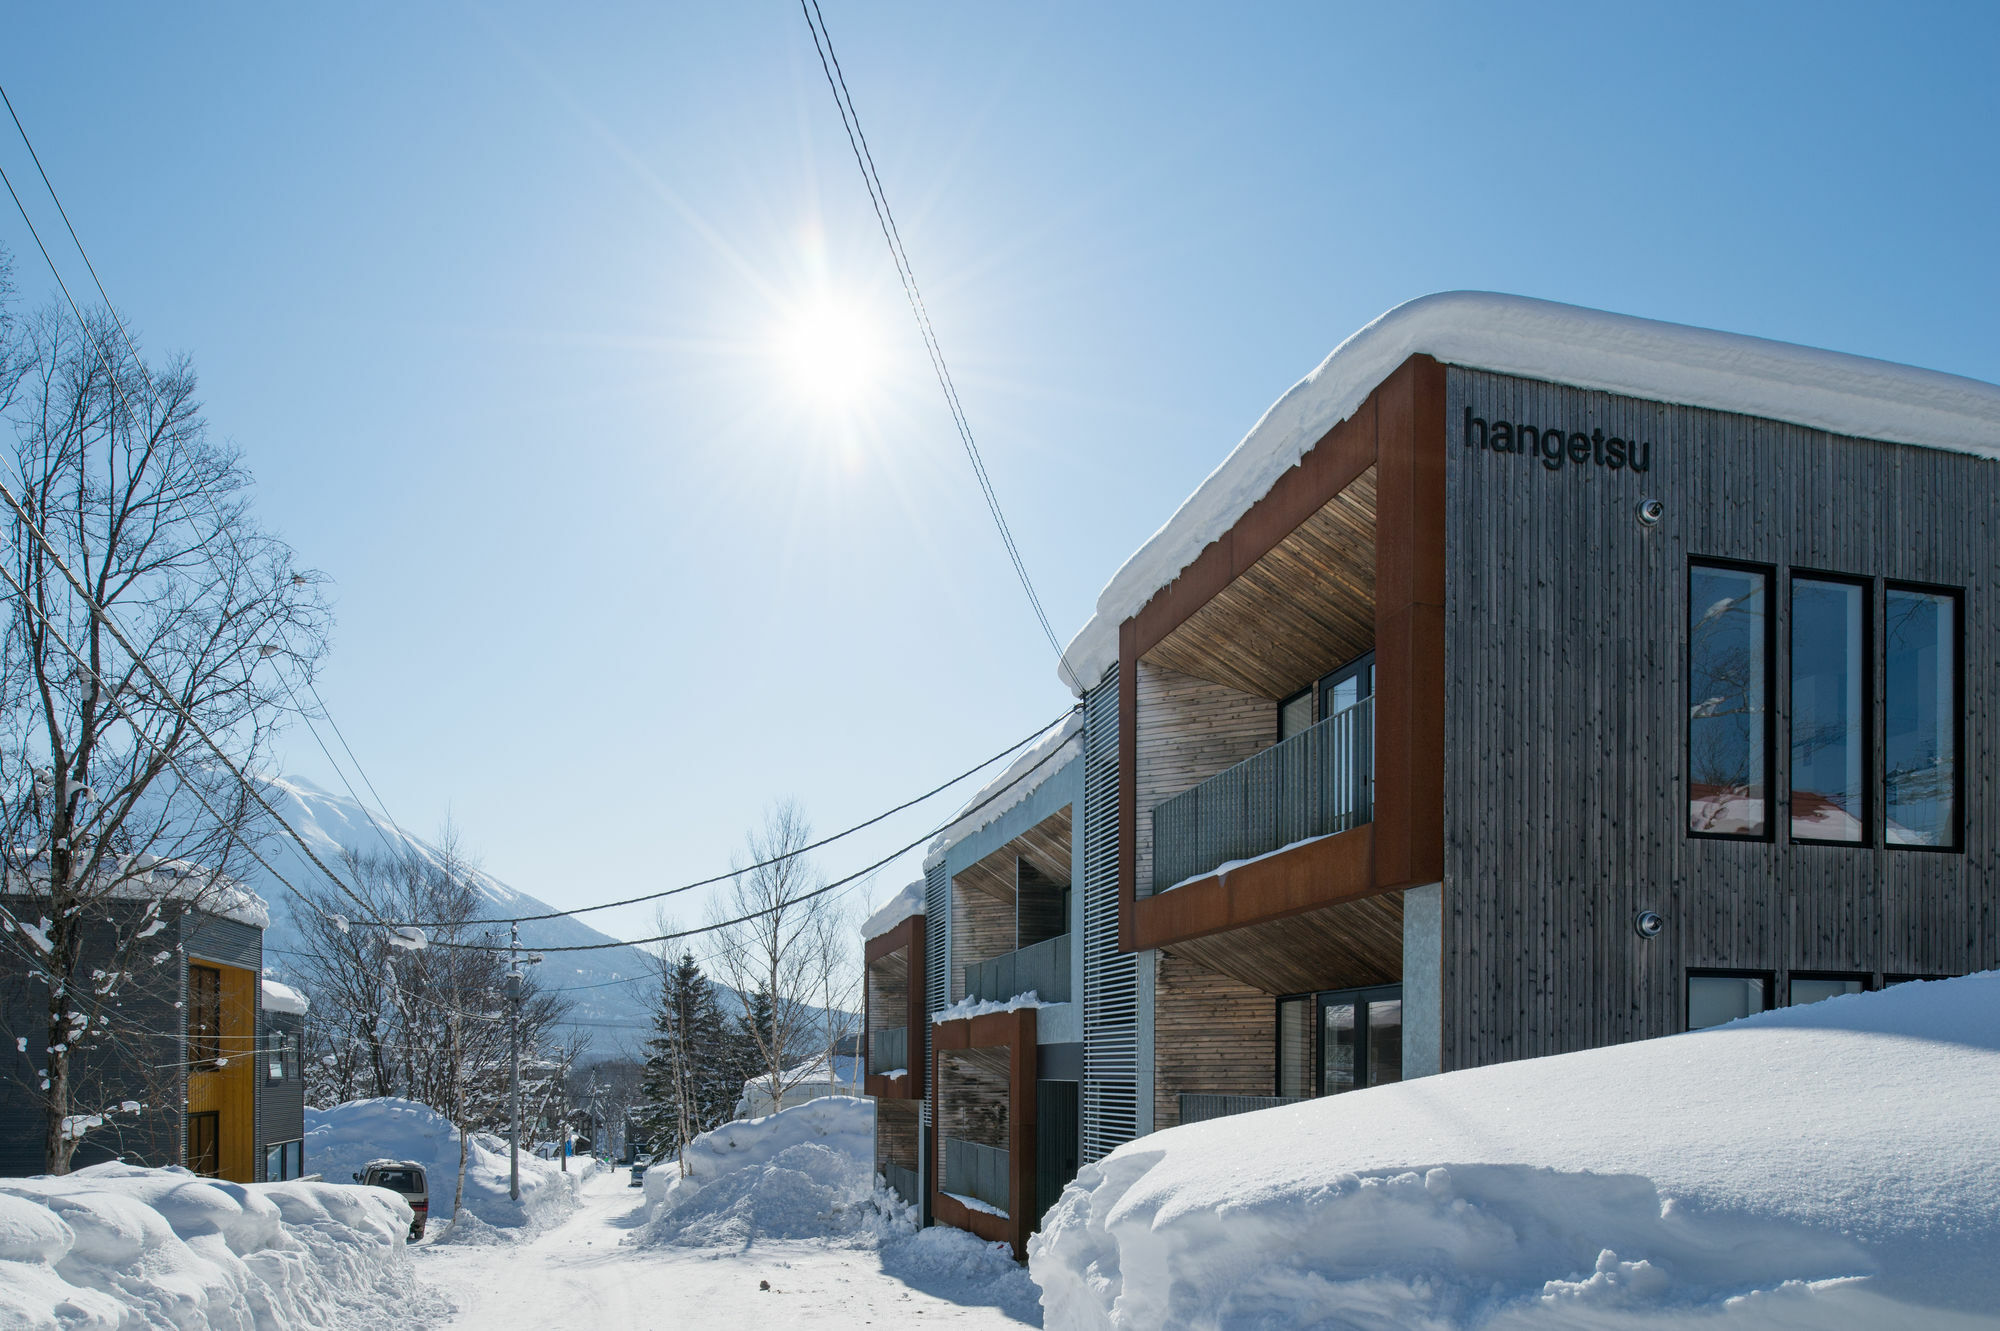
top-left (1146, 466), bottom-right (1376, 699)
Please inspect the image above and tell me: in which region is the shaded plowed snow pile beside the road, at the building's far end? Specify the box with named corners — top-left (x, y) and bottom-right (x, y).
top-left (638, 1095), bottom-right (1040, 1321)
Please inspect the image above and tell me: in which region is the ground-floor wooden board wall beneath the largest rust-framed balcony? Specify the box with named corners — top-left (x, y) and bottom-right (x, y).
top-left (1152, 951), bottom-right (1278, 1129)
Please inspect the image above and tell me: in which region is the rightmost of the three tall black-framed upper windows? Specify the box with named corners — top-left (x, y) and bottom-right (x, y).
top-left (1882, 588), bottom-right (1958, 849)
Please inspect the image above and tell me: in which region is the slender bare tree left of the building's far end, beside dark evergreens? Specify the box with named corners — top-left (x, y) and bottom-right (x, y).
top-left (712, 799), bottom-right (832, 1105)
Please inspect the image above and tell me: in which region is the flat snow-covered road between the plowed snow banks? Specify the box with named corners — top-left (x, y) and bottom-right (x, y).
top-left (412, 1171), bottom-right (1048, 1331)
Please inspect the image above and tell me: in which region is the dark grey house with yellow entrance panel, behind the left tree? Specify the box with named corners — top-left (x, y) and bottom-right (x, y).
top-left (0, 859), bottom-right (306, 1183)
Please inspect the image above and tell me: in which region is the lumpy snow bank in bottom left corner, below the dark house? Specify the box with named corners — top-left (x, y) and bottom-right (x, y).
top-left (0, 1165), bottom-right (442, 1331)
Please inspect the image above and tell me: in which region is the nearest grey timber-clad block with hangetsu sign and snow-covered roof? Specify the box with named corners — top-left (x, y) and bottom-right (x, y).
top-left (868, 294), bottom-right (2000, 1255)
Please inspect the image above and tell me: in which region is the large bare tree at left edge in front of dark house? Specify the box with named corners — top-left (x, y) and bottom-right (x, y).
top-left (0, 285), bottom-right (328, 1173)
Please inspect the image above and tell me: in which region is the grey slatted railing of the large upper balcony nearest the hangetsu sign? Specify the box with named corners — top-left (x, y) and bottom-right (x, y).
top-left (1152, 697), bottom-right (1374, 893)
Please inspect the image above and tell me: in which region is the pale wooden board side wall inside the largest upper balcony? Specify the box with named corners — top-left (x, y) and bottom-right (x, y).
top-left (1136, 662), bottom-right (1278, 895)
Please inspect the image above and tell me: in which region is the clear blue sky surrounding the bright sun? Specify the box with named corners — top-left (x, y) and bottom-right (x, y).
top-left (0, 0), bottom-right (2000, 933)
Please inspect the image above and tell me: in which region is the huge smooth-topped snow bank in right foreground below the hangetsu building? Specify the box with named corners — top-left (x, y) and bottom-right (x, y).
top-left (1030, 973), bottom-right (2000, 1331)
